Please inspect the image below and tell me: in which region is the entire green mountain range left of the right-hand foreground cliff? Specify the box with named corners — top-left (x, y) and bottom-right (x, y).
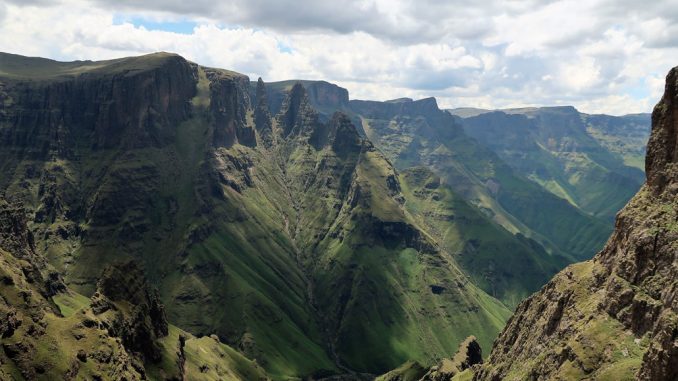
top-left (0, 53), bottom-right (660, 379)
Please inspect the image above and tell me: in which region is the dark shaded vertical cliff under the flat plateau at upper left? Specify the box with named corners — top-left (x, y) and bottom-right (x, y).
top-left (0, 52), bottom-right (195, 155)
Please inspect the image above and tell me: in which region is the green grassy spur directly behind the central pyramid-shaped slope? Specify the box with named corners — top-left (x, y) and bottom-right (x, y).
top-left (401, 167), bottom-right (567, 307)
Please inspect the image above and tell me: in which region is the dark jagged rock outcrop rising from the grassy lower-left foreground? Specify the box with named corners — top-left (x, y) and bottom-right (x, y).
top-left (92, 261), bottom-right (168, 361)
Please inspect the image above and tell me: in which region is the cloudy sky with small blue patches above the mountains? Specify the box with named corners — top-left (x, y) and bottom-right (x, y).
top-left (0, 0), bottom-right (678, 115)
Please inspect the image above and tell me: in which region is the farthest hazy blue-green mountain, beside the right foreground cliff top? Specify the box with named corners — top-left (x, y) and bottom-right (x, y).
top-left (452, 107), bottom-right (650, 220)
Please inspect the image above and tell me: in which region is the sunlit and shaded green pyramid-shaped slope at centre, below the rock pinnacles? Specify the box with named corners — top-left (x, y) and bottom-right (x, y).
top-left (306, 147), bottom-right (508, 372)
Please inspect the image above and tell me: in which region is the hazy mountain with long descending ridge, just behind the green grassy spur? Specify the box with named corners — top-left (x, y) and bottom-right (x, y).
top-left (350, 98), bottom-right (611, 258)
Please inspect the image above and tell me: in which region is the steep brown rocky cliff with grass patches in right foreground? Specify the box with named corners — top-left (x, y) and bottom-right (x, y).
top-left (474, 68), bottom-right (678, 381)
